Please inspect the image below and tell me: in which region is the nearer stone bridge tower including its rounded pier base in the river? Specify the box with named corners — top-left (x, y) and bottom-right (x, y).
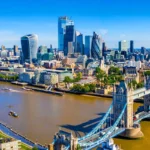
top-left (113, 80), bottom-right (144, 138)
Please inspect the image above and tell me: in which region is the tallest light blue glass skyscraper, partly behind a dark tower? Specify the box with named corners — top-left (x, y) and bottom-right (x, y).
top-left (58, 16), bottom-right (74, 51)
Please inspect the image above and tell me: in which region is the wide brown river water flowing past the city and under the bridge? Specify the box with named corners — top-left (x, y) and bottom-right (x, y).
top-left (0, 83), bottom-right (150, 150)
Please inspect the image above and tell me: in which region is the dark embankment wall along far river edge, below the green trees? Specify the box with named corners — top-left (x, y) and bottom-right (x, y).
top-left (54, 88), bottom-right (112, 98)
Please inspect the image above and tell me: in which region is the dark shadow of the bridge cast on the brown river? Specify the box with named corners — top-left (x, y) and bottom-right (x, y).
top-left (60, 113), bottom-right (105, 137)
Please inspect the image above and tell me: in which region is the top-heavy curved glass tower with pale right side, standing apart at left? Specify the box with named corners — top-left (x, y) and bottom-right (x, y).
top-left (21, 34), bottom-right (38, 63)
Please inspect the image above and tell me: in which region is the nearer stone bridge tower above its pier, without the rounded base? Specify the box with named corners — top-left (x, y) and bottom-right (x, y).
top-left (113, 80), bottom-right (133, 128)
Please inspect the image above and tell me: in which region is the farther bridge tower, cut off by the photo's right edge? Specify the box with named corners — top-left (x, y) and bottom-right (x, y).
top-left (144, 76), bottom-right (150, 112)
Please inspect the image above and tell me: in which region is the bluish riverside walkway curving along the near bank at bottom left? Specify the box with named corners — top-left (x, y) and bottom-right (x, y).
top-left (0, 123), bottom-right (47, 150)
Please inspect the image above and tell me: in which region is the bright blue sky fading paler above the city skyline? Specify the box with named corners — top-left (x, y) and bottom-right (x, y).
top-left (0, 0), bottom-right (150, 48)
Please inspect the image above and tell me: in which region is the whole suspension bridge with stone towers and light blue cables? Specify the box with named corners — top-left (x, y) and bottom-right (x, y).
top-left (51, 77), bottom-right (150, 150)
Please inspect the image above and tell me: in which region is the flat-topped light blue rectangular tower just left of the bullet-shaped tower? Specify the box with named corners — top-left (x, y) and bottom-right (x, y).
top-left (84, 35), bottom-right (93, 58)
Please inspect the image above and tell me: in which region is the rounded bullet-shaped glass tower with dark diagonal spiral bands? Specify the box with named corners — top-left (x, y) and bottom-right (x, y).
top-left (91, 32), bottom-right (102, 60)
